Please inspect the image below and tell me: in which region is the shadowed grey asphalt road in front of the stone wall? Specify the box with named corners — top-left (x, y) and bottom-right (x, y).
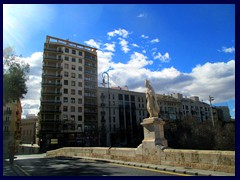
top-left (12, 156), bottom-right (186, 176)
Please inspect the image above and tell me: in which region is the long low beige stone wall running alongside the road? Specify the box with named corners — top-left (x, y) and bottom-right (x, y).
top-left (47, 145), bottom-right (235, 173)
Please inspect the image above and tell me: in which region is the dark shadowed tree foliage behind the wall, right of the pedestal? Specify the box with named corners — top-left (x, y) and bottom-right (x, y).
top-left (165, 117), bottom-right (235, 150)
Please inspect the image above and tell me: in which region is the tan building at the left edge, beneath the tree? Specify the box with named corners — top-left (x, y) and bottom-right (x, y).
top-left (3, 100), bottom-right (22, 157)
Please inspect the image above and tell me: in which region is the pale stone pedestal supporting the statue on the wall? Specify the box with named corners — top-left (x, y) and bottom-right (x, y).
top-left (141, 117), bottom-right (168, 149)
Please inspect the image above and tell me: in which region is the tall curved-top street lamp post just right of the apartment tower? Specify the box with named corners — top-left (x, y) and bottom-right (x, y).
top-left (102, 72), bottom-right (111, 146)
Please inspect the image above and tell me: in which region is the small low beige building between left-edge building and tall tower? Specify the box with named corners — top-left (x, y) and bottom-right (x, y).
top-left (21, 115), bottom-right (38, 144)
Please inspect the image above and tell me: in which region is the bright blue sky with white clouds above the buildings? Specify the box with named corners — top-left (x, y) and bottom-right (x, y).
top-left (3, 4), bottom-right (235, 117)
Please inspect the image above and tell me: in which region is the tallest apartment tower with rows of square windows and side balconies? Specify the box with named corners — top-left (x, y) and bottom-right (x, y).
top-left (39, 36), bottom-right (98, 151)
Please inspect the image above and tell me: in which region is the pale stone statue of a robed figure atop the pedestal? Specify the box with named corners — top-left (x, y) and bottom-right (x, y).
top-left (145, 80), bottom-right (160, 118)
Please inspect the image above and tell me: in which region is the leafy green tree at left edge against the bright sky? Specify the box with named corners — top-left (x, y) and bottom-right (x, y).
top-left (3, 47), bottom-right (29, 106)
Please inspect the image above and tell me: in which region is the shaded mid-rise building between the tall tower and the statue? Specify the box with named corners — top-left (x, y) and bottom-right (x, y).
top-left (98, 87), bottom-right (147, 147)
